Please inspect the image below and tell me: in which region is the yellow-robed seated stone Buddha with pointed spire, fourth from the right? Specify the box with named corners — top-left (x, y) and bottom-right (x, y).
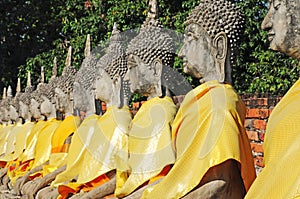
top-left (46, 24), bottom-right (131, 198)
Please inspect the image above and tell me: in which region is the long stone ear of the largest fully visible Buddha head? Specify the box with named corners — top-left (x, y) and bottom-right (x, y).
top-left (213, 32), bottom-right (227, 82)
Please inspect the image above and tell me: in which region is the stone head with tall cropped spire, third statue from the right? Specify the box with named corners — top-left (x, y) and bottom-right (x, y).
top-left (126, 0), bottom-right (190, 98)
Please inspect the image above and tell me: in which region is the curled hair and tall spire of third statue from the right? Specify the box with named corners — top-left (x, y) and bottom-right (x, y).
top-left (127, 0), bottom-right (175, 66)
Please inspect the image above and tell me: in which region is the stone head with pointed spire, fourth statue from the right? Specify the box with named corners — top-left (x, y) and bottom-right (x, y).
top-left (96, 23), bottom-right (130, 107)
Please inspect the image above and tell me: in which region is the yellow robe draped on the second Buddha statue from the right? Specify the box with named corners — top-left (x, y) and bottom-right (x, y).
top-left (142, 81), bottom-right (255, 199)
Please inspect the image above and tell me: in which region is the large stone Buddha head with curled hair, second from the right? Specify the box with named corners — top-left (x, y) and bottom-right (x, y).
top-left (179, 0), bottom-right (244, 83)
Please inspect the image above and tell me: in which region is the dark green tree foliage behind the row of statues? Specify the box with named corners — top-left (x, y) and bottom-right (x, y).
top-left (0, 0), bottom-right (300, 95)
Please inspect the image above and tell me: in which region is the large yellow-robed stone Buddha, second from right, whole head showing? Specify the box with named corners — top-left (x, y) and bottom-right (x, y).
top-left (142, 0), bottom-right (255, 198)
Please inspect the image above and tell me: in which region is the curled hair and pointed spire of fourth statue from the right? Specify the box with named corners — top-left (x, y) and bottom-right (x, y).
top-left (97, 23), bottom-right (127, 80)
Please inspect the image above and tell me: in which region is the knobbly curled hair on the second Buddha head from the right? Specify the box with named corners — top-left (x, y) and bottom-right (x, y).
top-left (185, 0), bottom-right (245, 67)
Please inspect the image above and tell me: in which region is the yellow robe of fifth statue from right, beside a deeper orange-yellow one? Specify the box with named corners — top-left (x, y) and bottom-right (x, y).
top-left (51, 114), bottom-right (100, 187)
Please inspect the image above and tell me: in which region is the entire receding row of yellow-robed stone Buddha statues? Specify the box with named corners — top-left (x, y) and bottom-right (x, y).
top-left (0, 0), bottom-right (300, 199)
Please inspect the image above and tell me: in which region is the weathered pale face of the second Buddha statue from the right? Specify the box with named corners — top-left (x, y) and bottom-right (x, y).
top-left (179, 23), bottom-right (227, 83)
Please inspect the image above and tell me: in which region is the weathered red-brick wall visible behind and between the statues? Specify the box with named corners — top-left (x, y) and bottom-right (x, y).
top-left (102, 94), bottom-right (281, 173)
